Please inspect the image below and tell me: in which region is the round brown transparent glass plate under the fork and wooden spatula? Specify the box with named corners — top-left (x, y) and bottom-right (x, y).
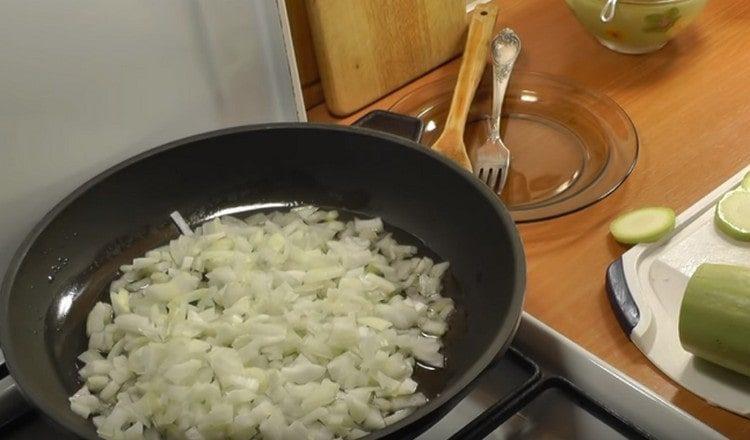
top-left (390, 72), bottom-right (638, 222)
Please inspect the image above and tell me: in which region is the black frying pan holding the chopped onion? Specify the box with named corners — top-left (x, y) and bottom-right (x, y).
top-left (0, 112), bottom-right (525, 439)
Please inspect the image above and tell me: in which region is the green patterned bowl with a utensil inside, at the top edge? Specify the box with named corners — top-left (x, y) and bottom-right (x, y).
top-left (565, 0), bottom-right (708, 54)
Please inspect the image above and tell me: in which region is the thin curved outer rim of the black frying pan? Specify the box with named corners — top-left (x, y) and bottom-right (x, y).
top-left (0, 122), bottom-right (526, 440)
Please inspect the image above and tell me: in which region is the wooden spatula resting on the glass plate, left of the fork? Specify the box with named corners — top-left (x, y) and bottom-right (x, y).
top-left (432, 3), bottom-right (497, 171)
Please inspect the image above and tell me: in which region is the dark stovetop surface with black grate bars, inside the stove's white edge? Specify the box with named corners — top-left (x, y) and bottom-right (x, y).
top-left (420, 347), bottom-right (652, 440)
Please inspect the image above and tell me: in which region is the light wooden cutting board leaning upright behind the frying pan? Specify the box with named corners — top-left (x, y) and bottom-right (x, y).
top-left (307, 0), bottom-right (466, 115)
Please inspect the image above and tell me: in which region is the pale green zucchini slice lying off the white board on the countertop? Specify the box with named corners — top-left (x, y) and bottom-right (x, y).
top-left (609, 206), bottom-right (676, 244)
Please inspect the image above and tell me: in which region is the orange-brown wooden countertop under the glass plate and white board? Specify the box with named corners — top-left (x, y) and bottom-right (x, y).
top-left (308, 0), bottom-right (750, 438)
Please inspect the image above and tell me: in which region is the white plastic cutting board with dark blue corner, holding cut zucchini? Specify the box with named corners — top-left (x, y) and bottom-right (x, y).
top-left (622, 167), bottom-right (750, 417)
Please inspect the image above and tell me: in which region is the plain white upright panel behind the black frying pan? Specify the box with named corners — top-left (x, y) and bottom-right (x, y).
top-left (0, 0), bottom-right (305, 276)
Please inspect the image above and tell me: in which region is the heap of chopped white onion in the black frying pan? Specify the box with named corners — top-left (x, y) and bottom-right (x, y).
top-left (70, 206), bottom-right (454, 440)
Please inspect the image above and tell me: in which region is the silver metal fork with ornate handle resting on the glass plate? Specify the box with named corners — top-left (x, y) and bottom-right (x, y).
top-left (474, 28), bottom-right (521, 194)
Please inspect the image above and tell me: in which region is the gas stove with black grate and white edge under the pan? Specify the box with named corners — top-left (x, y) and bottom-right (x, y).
top-left (0, 314), bottom-right (724, 440)
